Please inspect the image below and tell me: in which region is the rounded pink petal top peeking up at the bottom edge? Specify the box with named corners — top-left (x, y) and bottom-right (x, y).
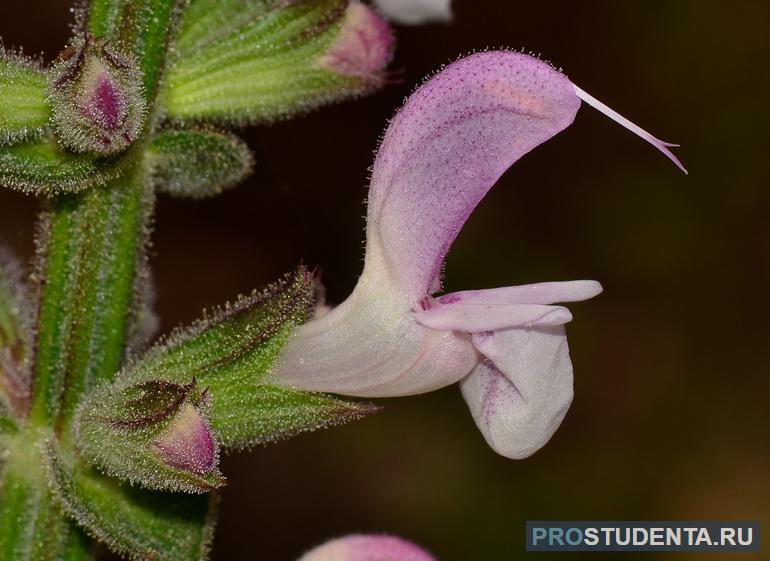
top-left (299, 534), bottom-right (435, 561)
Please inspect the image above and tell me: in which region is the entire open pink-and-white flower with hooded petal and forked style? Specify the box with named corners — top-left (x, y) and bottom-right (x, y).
top-left (271, 51), bottom-right (680, 458)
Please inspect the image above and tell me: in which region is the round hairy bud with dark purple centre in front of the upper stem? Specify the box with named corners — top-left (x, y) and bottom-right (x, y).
top-left (49, 34), bottom-right (145, 154)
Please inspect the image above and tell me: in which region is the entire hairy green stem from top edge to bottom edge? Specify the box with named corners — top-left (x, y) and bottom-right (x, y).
top-left (0, 0), bottom-right (180, 561)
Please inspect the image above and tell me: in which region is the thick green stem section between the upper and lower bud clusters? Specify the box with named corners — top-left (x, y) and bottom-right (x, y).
top-left (31, 165), bottom-right (152, 428)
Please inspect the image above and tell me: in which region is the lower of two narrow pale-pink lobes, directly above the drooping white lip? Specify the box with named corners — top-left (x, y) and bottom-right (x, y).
top-left (414, 304), bottom-right (572, 333)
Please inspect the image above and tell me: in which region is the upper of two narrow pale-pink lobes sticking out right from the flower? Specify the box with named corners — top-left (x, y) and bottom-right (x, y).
top-left (436, 280), bottom-right (602, 304)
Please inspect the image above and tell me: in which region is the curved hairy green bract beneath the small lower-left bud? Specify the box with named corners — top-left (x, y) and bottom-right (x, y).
top-left (45, 441), bottom-right (218, 561)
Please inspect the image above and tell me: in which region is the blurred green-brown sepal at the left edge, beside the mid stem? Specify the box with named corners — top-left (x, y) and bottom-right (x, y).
top-left (0, 247), bottom-right (34, 416)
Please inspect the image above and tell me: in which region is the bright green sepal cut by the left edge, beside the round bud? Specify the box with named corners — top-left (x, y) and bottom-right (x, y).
top-left (0, 50), bottom-right (51, 144)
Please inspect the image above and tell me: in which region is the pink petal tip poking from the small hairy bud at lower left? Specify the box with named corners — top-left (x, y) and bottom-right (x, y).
top-left (155, 403), bottom-right (216, 474)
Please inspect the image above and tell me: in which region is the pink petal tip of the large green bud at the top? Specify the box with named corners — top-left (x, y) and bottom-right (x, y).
top-left (319, 0), bottom-right (393, 84)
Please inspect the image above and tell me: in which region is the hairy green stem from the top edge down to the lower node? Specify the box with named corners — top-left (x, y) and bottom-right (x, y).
top-left (31, 0), bottom-right (178, 428)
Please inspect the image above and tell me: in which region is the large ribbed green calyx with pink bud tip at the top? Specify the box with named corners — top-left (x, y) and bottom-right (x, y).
top-left (159, 0), bottom-right (392, 124)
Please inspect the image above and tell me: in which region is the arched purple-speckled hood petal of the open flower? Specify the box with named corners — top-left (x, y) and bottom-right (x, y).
top-left (367, 51), bottom-right (580, 306)
